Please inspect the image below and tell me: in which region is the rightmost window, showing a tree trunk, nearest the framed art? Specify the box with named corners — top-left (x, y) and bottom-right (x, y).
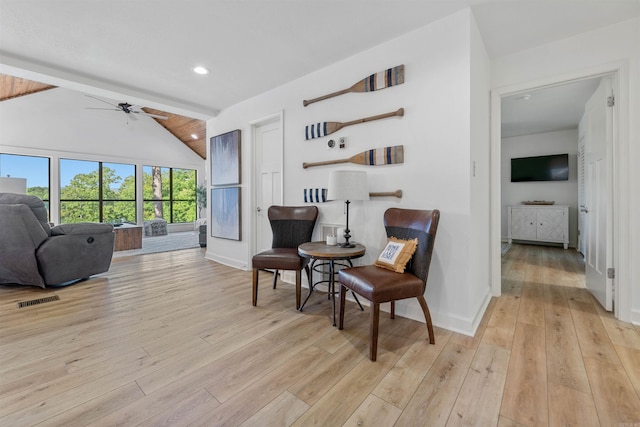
top-left (142, 166), bottom-right (197, 223)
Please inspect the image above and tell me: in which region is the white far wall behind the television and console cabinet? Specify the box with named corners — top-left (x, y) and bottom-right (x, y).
top-left (500, 129), bottom-right (578, 247)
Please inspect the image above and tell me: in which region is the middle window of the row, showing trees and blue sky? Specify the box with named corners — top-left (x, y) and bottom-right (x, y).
top-left (60, 159), bottom-right (136, 224)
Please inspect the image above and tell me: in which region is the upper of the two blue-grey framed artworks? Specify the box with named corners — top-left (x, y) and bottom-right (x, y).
top-left (210, 129), bottom-right (240, 185)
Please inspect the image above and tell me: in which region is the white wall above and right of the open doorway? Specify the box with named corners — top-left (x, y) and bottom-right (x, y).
top-left (491, 18), bottom-right (640, 324)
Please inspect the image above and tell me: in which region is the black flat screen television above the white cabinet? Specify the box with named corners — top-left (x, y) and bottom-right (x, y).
top-left (511, 154), bottom-right (569, 182)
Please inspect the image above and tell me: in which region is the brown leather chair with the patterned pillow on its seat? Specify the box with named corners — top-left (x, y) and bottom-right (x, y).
top-left (338, 208), bottom-right (440, 361)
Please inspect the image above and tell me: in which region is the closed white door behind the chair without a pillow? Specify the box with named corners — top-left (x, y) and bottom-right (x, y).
top-left (253, 116), bottom-right (283, 253)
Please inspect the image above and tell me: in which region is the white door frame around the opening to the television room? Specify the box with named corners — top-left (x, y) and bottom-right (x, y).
top-left (490, 61), bottom-right (631, 322)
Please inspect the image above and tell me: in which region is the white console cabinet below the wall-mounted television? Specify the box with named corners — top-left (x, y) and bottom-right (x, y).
top-left (507, 205), bottom-right (569, 249)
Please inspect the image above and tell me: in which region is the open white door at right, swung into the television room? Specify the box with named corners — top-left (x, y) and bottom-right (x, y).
top-left (584, 77), bottom-right (613, 311)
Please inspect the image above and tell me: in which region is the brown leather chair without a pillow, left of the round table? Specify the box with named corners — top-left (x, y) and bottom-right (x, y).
top-left (251, 206), bottom-right (318, 309)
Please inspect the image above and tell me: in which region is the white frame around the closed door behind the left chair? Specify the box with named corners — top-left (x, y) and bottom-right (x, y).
top-left (247, 110), bottom-right (284, 260)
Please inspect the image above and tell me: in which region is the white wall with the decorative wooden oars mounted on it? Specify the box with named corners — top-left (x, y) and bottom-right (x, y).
top-left (207, 10), bottom-right (489, 334)
